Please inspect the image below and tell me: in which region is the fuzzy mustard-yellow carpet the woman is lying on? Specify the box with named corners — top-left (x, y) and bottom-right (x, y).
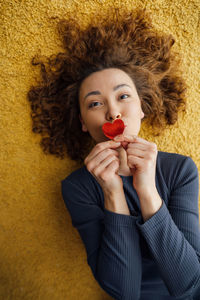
top-left (0, 0), bottom-right (200, 300)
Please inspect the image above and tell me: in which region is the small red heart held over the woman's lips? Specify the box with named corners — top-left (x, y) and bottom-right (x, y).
top-left (102, 119), bottom-right (126, 139)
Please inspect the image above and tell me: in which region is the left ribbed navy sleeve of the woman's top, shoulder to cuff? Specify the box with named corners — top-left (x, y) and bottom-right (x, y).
top-left (62, 178), bottom-right (142, 300)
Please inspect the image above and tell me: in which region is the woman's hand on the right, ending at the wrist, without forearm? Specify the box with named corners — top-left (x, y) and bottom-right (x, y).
top-left (114, 135), bottom-right (158, 195)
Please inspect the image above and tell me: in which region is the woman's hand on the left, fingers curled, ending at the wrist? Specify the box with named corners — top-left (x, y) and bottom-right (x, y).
top-left (84, 140), bottom-right (123, 193)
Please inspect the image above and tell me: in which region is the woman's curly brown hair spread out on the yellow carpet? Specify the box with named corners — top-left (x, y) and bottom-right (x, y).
top-left (28, 9), bottom-right (186, 162)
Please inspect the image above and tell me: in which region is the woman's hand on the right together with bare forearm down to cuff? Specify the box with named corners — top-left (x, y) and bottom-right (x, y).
top-left (114, 135), bottom-right (162, 221)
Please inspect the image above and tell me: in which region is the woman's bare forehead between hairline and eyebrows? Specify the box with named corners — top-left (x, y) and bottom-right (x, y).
top-left (80, 68), bottom-right (133, 95)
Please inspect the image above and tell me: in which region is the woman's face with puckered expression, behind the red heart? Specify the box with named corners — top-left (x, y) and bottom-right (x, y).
top-left (79, 68), bottom-right (144, 143)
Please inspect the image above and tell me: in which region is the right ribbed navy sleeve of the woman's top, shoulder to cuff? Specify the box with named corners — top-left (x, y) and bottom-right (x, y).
top-left (137, 157), bottom-right (200, 299)
